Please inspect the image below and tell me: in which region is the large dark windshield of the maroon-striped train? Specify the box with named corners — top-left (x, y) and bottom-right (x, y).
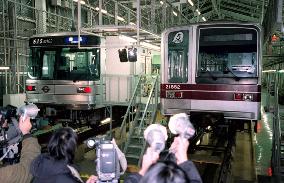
top-left (196, 27), bottom-right (258, 83)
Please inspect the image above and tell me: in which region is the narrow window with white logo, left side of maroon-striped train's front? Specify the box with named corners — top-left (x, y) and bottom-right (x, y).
top-left (167, 30), bottom-right (188, 83)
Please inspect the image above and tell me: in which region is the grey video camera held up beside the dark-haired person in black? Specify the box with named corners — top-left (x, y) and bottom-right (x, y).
top-left (86, 136), bottom-right (120, 183)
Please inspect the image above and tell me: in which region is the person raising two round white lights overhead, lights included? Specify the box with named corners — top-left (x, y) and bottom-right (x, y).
top-left (125, 113), bottom-right (202, 183)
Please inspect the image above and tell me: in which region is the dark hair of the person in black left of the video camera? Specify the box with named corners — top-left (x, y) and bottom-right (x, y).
top-left (47, 128), bottom-right (77, 164)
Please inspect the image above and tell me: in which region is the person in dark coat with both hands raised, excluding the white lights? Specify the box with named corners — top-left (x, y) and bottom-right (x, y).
top-left (124, 137), bottom-right (202, 183)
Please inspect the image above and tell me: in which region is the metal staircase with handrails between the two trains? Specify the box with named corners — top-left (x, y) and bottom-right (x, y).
top-left (120, 75), bottom-right (159, 166)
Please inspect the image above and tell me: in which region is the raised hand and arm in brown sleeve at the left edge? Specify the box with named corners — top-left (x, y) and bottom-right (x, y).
top-left (0, 105), bottom-right (40, 183)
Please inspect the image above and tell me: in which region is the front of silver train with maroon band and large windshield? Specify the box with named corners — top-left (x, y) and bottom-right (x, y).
top-left (160, 22), bottom-right (262, 121)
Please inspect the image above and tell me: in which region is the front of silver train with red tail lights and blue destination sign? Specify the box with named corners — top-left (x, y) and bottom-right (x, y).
top-left (26, 32), bottom-right (100, 110)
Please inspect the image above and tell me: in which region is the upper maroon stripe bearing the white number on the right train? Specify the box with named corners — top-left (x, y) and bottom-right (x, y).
top-left (160, 84), bottom-right (261, 92)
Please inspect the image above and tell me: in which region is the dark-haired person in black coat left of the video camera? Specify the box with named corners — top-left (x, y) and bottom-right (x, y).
top-left (30, 128), bottom-right (97, 183)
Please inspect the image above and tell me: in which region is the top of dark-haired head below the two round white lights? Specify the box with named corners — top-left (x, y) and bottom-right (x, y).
top-left (140, 161), bottom-right (190, 183)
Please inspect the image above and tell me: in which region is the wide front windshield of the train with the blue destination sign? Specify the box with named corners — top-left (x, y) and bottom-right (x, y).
top-left (28, 47), bottom-right (100, 81)
